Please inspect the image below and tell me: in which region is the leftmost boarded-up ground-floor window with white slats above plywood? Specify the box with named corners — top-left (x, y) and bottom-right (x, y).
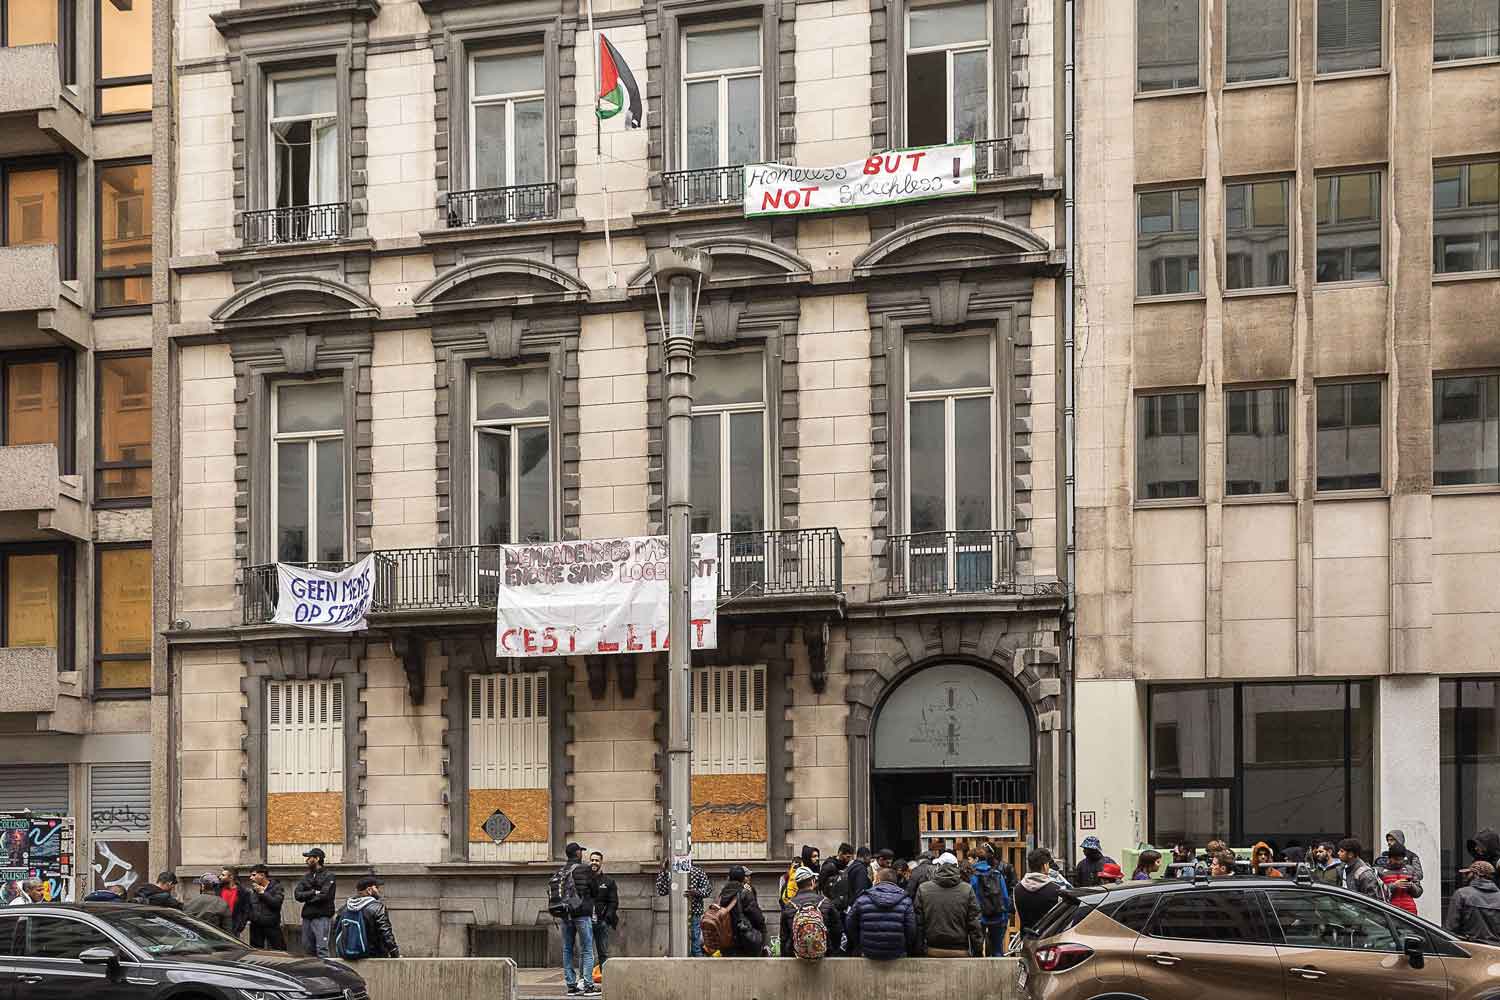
top-left (266, 679), bottom-right (344, 865)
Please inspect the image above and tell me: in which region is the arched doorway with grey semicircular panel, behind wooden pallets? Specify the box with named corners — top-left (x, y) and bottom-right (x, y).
top-left (870, 661), bottom-right (1035, 856)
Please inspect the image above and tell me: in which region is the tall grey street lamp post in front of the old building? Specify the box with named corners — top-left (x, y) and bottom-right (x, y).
top-left (651, 247), bottom-right (714, 958)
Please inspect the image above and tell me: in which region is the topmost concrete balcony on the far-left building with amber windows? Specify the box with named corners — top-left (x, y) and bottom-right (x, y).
top-left (0, 45), bottom-right (90, 157)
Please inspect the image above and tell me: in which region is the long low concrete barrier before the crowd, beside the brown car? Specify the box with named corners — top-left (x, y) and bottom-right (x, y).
top-left (603, 958), bottom-right (1023, 1000)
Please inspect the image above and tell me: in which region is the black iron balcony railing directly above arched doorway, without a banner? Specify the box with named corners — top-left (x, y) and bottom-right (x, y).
top-left (887, 531), bottom-right (1062, 598)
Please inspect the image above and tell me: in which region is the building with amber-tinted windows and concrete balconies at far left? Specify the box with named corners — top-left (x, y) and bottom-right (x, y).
top-left (0, 0), bottom-right (156, 895)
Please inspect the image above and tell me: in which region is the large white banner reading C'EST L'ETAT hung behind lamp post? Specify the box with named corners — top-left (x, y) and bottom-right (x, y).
top-left (495, 535), bottom-right (719, 657)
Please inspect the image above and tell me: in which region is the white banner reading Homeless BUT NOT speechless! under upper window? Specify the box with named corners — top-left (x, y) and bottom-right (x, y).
top-left (744, 142), bottom-right (974, 216)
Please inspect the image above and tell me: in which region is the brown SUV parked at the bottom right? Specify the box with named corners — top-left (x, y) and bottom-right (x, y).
top-left (1022, 879), bottom-right (1500, 1000)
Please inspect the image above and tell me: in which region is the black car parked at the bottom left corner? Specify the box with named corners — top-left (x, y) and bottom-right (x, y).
top-left (0, 903), bottom-right (369, 1000)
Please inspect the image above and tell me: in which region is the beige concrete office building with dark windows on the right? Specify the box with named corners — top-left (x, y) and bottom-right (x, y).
top-left (1076, 0), bottom-right (1500, 915)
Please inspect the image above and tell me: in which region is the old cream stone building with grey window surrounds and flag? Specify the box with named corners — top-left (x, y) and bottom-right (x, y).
top-left (158, 0), bottom-right (1071, 963)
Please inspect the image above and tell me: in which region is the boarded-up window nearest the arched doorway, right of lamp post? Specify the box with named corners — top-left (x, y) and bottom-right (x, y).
top-left (693, 667), bottom-right (767, 859)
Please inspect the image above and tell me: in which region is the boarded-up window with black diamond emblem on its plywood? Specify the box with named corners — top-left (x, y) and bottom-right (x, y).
top-left (468, 673), bottom-right (552, 861)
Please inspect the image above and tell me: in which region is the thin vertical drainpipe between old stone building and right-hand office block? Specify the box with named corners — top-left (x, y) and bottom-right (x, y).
top-left (1058, 0), bottom-right (1079, 858)
